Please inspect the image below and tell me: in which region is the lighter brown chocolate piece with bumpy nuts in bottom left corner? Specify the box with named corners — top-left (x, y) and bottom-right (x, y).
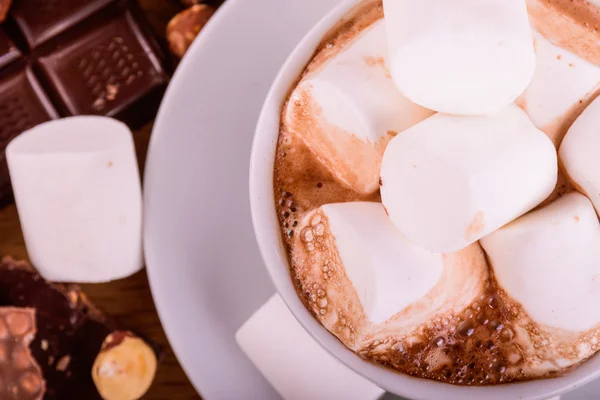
top-left (0, 307), bottom-right (45, 400)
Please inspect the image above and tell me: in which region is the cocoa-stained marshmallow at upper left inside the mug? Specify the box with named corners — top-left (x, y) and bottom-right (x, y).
top-left (285, 21), bottom-right (432, 193)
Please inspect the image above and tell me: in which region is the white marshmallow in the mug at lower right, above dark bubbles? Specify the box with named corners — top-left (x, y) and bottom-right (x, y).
top-left (481, 193), bottom-right (600, 332)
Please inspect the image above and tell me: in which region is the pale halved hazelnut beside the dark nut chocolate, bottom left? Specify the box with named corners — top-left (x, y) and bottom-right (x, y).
top-left (92, 331), bottom-right (157, 400)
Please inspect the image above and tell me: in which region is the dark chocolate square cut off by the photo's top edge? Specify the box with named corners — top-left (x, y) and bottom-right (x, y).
top-left (11, 0), bottom-right (114, 49)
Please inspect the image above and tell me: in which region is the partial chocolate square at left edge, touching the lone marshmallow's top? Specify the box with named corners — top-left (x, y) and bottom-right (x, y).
top-left (0, 67), bottom-right (58, 205)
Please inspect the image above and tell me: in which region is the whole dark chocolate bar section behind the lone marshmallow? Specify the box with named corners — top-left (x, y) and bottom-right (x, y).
top-left (0, 0), bottom-right (169, 206)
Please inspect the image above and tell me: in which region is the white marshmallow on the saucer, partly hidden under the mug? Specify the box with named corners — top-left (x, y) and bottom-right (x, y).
top-left (235, 294), bottom-right (384, 400)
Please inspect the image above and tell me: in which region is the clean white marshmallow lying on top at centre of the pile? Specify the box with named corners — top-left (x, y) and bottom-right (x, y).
top-left (381, 105), bottom-right (558, 253)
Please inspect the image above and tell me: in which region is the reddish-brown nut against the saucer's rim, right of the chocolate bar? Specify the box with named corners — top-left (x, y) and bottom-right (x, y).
top-left (166, 4), bottom-right (215, 58)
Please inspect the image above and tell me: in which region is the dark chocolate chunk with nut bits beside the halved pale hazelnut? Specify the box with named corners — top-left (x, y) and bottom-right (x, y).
top-left (0, 258), bottom-right (161, 400)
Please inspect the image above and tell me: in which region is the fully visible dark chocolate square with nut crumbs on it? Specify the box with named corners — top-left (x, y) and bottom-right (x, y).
top-left (38, 10), bottom-right (168, 123)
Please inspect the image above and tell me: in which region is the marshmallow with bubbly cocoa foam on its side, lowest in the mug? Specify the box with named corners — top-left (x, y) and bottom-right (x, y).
top-left (300, 202), bottom-right (489, 351)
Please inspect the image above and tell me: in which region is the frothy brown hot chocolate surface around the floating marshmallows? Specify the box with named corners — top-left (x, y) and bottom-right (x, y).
top-left (274, 0), bottom-right (600, 385)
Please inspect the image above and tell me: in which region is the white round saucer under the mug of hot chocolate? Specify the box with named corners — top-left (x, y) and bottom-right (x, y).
top-left (145, 0), bottom-right (600, 400)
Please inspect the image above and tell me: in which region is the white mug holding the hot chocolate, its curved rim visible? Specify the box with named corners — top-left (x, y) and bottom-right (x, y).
top-left (250, 0), bottom-right (600, 400)
